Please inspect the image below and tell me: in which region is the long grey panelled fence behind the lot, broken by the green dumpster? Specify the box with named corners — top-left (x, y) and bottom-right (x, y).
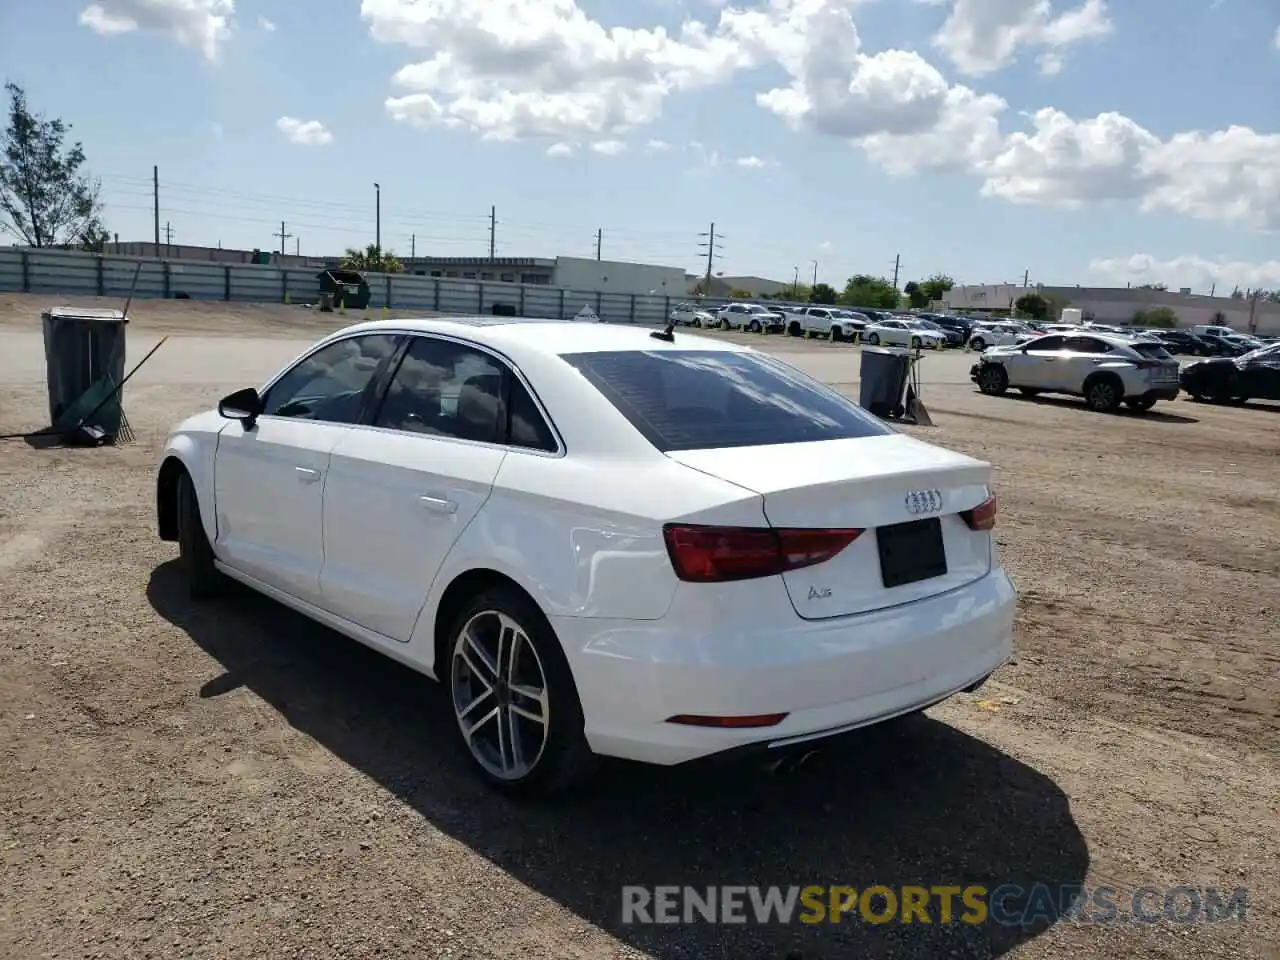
top-left (0, 248), bottom-right (685, 324)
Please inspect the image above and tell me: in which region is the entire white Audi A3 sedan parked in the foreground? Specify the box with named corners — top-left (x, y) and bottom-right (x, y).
top-left (156, 319), bottom-right (1015, 792)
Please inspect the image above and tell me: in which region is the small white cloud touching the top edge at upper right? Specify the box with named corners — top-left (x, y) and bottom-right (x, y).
top-left (933, 0), bottom-right (1112, 77)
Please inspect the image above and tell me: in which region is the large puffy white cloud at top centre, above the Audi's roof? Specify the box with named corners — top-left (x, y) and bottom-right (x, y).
top-left (361, 0), bottom-right (742, 140)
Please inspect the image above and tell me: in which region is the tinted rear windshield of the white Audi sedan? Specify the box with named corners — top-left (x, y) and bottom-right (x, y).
top-left (563, 349), bottom-right (893, 452)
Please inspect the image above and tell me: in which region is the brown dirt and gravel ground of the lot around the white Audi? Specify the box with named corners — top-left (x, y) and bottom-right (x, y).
top-left (0, 294), bottom-right (1280, 960)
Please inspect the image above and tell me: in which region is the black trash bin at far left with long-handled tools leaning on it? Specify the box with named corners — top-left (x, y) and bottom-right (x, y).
top-left (41, 307), bottom-right (129, 440)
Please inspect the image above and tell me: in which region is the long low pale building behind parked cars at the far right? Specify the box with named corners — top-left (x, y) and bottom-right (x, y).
top-left (942, 284), bottom-right (1280, 337)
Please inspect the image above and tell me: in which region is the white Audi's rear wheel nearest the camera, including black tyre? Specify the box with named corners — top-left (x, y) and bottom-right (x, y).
top-left (448, 588), bottom-right (596, 795)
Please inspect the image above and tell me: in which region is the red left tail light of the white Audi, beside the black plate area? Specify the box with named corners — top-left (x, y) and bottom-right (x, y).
top-left (662, 524), bottom-right (863, 584)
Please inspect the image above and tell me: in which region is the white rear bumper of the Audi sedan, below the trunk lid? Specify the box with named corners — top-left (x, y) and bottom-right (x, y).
top-left (552, 567), bottom-right (1016, 765)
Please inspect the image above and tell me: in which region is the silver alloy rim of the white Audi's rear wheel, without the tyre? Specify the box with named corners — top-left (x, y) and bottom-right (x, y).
top-left (451, 611), bottom-right (550, 781)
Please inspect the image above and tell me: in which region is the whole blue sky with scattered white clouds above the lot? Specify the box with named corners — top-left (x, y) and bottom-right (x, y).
top-left (0, 0), bottom-right (1280, 293)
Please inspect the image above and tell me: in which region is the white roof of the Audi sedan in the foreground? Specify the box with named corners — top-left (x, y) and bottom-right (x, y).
top-left (322, 316), bottom-right (754, 356)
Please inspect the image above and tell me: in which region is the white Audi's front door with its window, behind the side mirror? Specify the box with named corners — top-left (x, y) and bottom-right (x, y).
top-left (214, 334), bottom-right (399, 603)
